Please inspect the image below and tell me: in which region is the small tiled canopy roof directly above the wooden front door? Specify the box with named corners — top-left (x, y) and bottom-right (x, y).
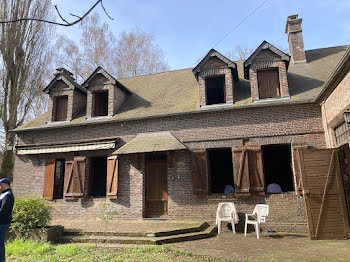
top-left (112, 132), bottom-right (187, 155)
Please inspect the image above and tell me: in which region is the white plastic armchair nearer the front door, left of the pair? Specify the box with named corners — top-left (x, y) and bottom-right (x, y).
top-left (216, 202), bottom-right (238, 234)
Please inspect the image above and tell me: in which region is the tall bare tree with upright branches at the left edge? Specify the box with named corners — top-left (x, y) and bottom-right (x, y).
top-left (0, 0), bottom-right (51, 178)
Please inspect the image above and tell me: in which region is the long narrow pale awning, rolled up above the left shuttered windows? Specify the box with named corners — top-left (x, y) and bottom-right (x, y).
top-left (16, 141), bottom-right (115, 155)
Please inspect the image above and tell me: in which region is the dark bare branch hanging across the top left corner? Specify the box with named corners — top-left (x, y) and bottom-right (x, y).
top-left (0, 0), bottom-right (113, 26)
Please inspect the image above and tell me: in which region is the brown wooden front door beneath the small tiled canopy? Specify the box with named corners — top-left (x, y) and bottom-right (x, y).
top-left (145, 154), bottom-right (168, 218)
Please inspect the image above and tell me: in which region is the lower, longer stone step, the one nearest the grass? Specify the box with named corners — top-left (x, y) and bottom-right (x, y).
top-left (59, 226), bottom-right (217, 245)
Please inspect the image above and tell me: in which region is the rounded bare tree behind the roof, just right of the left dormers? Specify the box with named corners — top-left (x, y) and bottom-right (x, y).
top-left (114, 28), bottom-right (169, 78)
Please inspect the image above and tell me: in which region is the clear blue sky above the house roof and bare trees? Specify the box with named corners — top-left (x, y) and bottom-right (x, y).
top-left (53, 0), bottom-right (350, 70)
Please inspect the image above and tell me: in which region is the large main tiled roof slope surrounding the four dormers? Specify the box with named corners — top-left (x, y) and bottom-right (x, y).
top-left (15, 46), bottom-right (349, 131)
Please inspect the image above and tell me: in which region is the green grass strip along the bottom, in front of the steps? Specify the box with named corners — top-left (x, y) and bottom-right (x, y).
top-left (6, 239), bottom-right (228, 262)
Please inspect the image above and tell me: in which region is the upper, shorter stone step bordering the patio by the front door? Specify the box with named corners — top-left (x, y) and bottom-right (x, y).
top-left (63, 222), bottom-right (209, 237)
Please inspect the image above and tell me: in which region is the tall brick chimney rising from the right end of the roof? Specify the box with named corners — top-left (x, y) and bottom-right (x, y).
top-left (285, 15), bottom-right (306, 64)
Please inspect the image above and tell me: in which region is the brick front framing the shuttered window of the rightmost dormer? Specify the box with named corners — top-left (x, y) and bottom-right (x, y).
top-left (249, 50), bottom-right (289, 101)
